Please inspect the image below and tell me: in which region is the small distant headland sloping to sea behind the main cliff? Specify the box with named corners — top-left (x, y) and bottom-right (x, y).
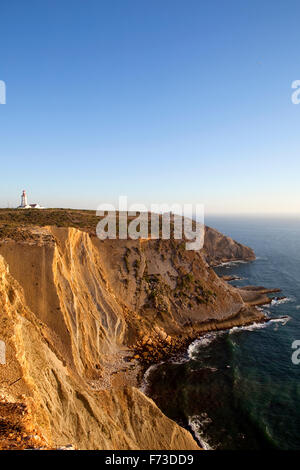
top-left (202, 227), bottom-right (255, 266)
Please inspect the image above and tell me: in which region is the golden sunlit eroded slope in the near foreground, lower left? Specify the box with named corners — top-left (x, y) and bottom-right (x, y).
top-left (0, 256), bottom-right (198, 449)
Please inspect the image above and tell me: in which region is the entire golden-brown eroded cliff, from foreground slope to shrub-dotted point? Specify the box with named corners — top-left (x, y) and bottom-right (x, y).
top-left (0, 227), bottom-right (262, 449)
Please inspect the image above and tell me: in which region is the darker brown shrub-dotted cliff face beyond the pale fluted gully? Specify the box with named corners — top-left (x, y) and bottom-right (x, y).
top-left (93, 238), bottom-right (260, 344)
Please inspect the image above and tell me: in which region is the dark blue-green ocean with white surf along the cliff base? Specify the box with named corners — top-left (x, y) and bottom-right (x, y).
top-left (144, 217), bottom-right (300, 450)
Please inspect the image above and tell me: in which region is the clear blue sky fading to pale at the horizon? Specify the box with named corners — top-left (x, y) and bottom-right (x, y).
top-left (0, 0), bottom-right (300, 214)
